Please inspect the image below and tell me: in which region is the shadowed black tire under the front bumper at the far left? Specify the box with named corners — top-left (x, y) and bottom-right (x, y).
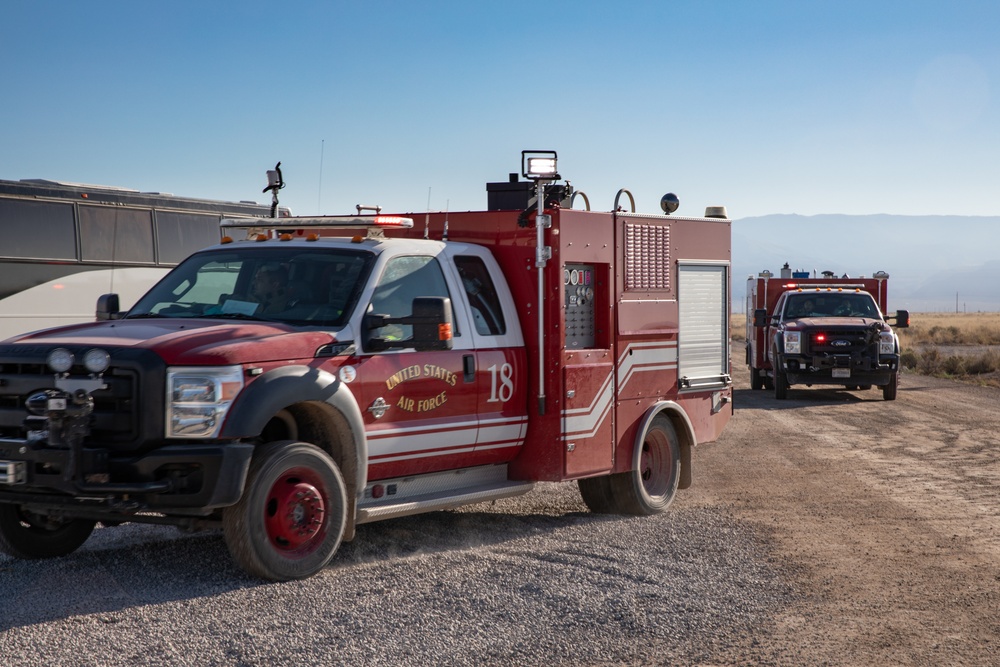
top-left (0, 503), bottom-right (97, 559)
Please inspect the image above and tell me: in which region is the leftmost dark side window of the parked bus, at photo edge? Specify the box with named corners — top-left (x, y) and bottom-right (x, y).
top-left (0, 199), bottom-right (76, 260)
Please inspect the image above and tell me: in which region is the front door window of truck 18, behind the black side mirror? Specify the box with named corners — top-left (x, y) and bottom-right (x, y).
top-left (368, 256), bottom-right (451, 340)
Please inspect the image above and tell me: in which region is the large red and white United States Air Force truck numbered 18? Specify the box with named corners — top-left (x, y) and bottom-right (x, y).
top-left (0, 152), bottom-right (732, 580)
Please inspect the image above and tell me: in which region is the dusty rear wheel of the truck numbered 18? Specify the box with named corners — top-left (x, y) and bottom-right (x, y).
top-left (608, 415), bottom-right (681, 515)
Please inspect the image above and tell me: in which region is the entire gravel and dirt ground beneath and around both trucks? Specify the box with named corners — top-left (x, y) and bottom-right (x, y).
top-left (0, 369), bottom-right (1000, 667)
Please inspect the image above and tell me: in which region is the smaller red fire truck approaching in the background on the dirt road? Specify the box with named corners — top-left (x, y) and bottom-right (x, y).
top-left (746, 264), bottom-right (909, 400)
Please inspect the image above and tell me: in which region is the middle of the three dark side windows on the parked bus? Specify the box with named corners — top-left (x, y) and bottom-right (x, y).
top-left (80, 206), bottom-right (153, 264)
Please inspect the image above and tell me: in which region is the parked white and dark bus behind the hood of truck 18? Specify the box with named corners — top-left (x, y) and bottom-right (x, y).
top-left (0, 179), bottom-right (288, 340)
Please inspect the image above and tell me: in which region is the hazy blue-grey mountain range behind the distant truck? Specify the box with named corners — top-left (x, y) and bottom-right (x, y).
top-left (733, 214), bottom-right (1000, 312)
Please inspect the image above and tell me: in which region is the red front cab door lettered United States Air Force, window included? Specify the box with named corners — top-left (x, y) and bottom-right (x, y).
top-left (352, 254), bottom-right (479, 480)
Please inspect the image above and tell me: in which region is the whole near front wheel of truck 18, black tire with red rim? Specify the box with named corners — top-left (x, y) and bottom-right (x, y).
top-left (222, 442), bottom-right (347, 581)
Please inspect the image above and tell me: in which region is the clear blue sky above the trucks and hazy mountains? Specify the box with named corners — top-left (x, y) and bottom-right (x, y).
top-left (0, 0), bottom-right (1000, 218)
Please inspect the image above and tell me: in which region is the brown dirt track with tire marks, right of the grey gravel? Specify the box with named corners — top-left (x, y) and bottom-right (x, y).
top-left (683, 368), bottom-right (1000, 665)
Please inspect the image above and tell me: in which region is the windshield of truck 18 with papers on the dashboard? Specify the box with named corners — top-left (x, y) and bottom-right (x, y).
top-left (126, 246), bottom-right (374, 327)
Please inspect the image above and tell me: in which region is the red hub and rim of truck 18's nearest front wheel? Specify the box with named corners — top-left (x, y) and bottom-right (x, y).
top-left (264, 468), bottom-right (327, 556)
